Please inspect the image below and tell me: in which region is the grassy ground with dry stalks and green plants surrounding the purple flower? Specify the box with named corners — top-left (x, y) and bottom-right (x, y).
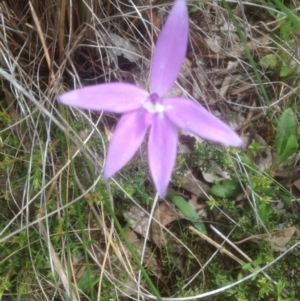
top-left (0, 0), bottom-right (300, 301)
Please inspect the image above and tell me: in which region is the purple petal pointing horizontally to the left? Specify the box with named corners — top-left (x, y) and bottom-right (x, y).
top-left (57, 83), bottom-right (149, 113)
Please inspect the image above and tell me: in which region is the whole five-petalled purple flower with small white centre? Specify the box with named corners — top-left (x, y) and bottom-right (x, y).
top-left (58, 0), bottom-right (242, 196)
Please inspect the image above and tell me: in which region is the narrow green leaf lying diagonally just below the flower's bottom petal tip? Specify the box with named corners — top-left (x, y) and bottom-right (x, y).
top-left (167, 190), bottom-right (207, 234)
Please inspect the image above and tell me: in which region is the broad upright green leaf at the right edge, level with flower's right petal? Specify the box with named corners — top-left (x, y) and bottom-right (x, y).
top-left (276, 108), bottom-right (296, 156)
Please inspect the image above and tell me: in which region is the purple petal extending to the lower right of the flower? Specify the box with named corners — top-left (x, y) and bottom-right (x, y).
top-left (163, 98), bottom-right (243, 146)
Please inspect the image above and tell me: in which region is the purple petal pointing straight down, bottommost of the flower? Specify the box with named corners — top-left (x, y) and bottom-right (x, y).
top-left (148, 113), bottom-right (177, 197)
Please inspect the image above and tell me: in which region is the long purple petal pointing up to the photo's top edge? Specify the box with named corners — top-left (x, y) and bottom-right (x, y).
top-left (151, 0), bottom-right (189, 96)
